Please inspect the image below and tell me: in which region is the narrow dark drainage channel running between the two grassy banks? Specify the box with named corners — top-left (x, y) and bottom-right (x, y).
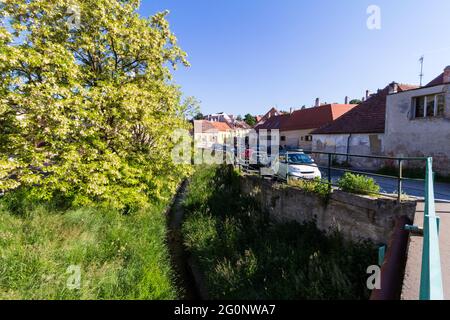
top-left (167, 180), bottom-right (202, 300)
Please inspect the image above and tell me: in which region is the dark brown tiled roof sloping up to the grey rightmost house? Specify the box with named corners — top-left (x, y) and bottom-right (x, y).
top-left (312, 84), bottom-right (417, 134)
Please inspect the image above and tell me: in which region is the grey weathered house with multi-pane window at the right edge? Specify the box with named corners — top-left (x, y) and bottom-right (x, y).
top-left (385, 66), bottom-right (450, 175)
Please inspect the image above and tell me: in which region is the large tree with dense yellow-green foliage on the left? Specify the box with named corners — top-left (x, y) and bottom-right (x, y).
top-left (0, 0), bottom-right (190, 211)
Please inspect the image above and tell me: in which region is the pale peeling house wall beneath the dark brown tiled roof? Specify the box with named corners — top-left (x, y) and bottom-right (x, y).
top-left (312, 133), bottom-right (385, 170)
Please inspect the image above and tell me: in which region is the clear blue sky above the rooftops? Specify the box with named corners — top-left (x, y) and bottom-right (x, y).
top-left (141, 0), bottom-right (450, 115)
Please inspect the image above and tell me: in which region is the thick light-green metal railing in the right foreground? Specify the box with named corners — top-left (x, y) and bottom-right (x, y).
top-left (420, 158), bottom-right (444, 300)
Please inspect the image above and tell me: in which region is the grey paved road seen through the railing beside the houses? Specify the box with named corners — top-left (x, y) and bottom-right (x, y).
top-left (322, 170), bottom-right (450, 202)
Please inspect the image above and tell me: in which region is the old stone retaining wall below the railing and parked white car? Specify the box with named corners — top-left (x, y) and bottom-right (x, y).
top-left (241, 176), bottom-right (416, 244)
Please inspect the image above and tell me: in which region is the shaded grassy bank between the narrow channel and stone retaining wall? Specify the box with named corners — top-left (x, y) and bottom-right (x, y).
top-left (183, 167), bottom-right (377, 299)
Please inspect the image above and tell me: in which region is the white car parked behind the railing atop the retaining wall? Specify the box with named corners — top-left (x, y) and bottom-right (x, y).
top-left (277, 151), bottom-right (322, 180)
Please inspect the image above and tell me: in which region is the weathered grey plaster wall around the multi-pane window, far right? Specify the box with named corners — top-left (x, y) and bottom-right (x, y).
top-left (385, 85), bottom-right (450, 175)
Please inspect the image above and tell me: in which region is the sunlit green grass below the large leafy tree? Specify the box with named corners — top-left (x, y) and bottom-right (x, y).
top-left (0, 191), bottom-right (178, 300)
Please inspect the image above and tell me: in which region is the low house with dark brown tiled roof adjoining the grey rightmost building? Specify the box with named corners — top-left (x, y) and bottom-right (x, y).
top-left (312, 84), bottom-right (416, 169)
